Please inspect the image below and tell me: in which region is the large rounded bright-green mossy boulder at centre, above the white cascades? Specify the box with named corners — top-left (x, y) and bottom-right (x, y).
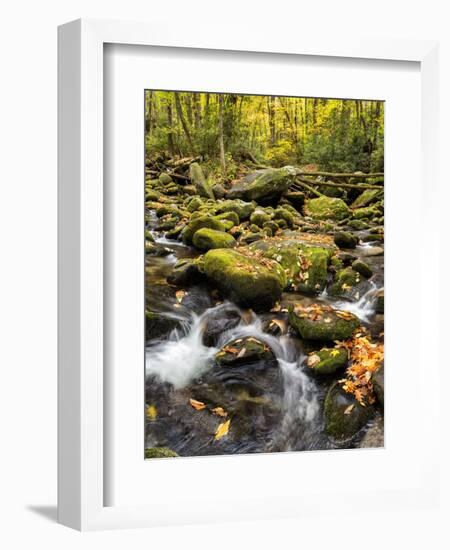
top-left (202, 249), bottom-right (286, 312)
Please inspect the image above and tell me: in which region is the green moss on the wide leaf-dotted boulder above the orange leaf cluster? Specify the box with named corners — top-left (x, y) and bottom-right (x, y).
top-left (289, 308), bottom-right (361, 342)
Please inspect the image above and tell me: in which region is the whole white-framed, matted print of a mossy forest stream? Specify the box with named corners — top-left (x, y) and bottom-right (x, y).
top-left (59, 20), bottom-right (438, 530)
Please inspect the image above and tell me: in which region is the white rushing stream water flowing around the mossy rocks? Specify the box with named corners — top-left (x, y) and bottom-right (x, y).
top-left (146, 220), bottom-right (383, 456)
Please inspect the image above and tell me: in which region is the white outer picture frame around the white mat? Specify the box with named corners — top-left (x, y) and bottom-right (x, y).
top-left (58, 20), bottom-right (439, 530)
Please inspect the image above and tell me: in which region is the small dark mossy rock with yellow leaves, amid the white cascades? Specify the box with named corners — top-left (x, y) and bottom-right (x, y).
top-left (215, 336), bottom-right (276, 367)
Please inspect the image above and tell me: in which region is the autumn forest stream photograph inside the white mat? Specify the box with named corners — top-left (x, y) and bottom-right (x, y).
top-left (143, 89), bottom-right (384, 459)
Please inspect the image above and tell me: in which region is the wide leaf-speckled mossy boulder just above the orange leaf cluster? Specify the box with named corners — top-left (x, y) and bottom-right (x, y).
top-left (289, 306), bottom-right (361, 342)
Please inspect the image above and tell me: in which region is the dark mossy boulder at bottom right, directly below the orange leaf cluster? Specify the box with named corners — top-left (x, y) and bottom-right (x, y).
top-left (324, 382), bottom-right (375, 440)
